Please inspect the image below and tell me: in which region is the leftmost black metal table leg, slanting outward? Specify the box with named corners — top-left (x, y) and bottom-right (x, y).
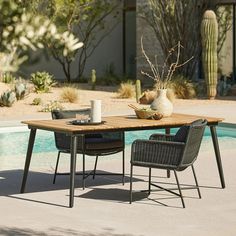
top-left (20, 128), bottom-right (36, 193)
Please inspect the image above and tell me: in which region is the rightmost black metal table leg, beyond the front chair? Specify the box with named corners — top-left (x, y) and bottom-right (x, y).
top-left (210, 126), bottom-right (225, 188)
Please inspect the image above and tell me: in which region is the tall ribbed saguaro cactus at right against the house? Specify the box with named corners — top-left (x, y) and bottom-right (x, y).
top-left (201, 10), bottom-right (218, 99)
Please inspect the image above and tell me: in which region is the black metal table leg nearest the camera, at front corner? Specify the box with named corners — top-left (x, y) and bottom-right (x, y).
top-left (69, 136), bottom-right (77, 207)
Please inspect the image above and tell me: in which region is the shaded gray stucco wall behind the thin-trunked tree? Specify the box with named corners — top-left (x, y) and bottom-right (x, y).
top-left (21, 5), bottom-right (123, 79)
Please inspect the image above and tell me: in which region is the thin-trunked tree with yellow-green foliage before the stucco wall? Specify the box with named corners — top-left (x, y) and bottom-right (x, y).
top-left (20, 0), bottom-right (121, 82)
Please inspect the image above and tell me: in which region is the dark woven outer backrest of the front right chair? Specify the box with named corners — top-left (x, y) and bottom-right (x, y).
top-left (178, 119), bottom-right (207, 170)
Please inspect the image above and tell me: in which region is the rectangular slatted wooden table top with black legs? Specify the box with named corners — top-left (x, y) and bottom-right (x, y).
top-left (22, 113), bottom-right (223, 134)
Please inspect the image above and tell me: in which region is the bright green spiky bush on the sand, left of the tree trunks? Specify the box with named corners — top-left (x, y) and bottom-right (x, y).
top-left (30, 71), bottom-right (55, 93)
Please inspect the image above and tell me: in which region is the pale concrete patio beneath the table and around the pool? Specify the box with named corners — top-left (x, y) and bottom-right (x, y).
top-left (0, 98), bottom-right (236, 236)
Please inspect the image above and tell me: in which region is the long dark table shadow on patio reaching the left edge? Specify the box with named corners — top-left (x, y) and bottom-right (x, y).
top-left (0, 170), bottom-right (143, 196)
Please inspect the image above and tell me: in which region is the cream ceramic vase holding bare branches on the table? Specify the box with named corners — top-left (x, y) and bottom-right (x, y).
top-left (151, 89), bottom-right (173, 117)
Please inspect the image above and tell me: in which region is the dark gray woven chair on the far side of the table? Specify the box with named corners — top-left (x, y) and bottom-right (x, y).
top-left (52, 109), bottom-right (125, 188)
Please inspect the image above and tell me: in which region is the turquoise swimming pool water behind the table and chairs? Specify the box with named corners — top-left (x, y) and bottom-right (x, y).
top-left (0, 127), bottom-right (236, 156)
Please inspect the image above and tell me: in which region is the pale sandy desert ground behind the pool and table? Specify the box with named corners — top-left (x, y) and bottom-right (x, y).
top-left (0, 83), bottom-right (236, 126)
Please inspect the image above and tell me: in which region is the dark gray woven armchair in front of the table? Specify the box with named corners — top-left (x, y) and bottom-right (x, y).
top-left (130, 120), bottom-right (207, 208)
